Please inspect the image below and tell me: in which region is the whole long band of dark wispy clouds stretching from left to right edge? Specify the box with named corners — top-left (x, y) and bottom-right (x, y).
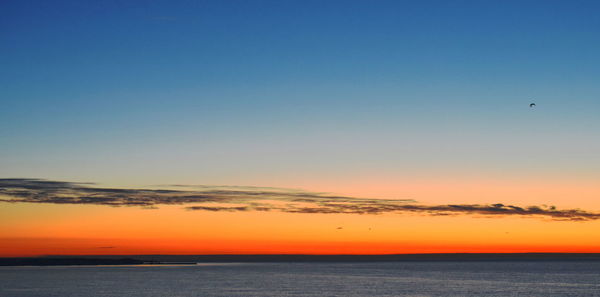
top-left (0, 178), bottom-right (600, 221)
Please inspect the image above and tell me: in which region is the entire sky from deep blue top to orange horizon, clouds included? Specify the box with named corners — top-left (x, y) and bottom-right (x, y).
top-left (0, 0), bottom-right (600, 256)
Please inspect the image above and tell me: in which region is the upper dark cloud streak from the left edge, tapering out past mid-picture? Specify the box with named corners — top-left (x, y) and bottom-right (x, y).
top-left (0, 178), bottom-right (413, 207)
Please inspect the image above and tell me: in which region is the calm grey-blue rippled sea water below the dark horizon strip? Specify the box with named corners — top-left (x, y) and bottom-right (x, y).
top-left (0, 262), bottom-right (600, 297)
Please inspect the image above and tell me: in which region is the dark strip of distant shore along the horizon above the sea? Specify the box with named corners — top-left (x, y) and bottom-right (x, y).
top-left (0, 253), bottom-right (600, 266)
